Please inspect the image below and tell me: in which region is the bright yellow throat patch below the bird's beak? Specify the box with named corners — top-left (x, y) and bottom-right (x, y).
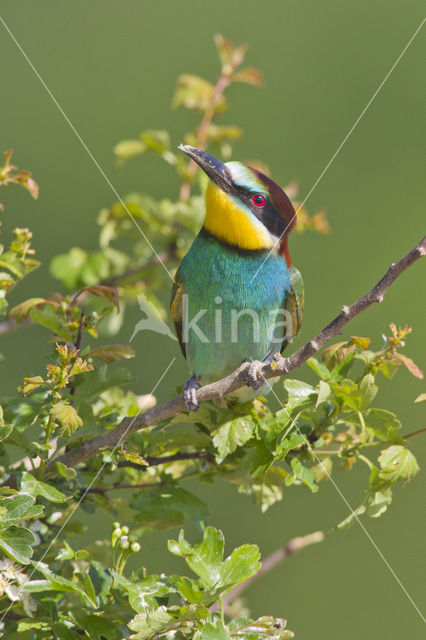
top-left (204, 182), bottom-right (274, 249)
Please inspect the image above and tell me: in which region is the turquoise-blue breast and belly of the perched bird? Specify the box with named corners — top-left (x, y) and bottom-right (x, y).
top-left (179, 234), bottom-right (290, 383)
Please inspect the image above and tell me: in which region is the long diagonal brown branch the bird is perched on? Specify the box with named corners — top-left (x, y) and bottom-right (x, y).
top-left (50, 236), bottom-right (426, 467)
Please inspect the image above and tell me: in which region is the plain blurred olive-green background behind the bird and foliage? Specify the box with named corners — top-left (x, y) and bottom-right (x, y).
top-left (0, 0), bottom-right (426, 640)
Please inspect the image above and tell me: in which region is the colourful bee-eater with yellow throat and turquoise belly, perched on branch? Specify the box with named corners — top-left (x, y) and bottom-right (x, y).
top-left (170, 145), bottom-right (304, 411)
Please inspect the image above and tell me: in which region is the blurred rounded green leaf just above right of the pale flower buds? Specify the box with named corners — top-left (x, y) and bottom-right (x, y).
top-left (130, 486), bottom-right (208, 530)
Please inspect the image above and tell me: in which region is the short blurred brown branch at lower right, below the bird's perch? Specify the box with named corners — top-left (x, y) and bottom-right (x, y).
top-left (210, 531), bottom-right (324, 612)
